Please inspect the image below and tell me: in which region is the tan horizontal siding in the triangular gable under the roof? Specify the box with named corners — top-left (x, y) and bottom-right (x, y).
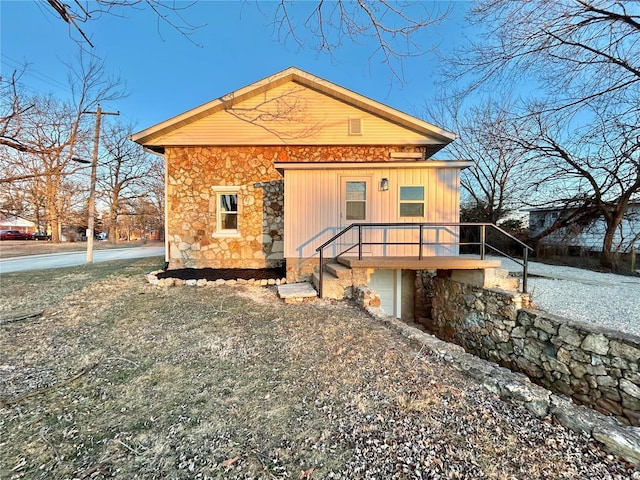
top-left (153, 82), bottom-right (438, 145)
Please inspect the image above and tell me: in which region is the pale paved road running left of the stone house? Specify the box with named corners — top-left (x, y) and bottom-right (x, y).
top-left (0, 246), bottom-right (164, 274)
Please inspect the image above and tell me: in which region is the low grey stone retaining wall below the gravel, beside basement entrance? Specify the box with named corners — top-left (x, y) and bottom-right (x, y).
top-left (423, 276), bottom-right (640, 426)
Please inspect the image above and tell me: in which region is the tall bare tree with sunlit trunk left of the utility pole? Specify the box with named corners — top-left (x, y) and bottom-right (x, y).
top-left (0, 56), bottom-right (122, 241)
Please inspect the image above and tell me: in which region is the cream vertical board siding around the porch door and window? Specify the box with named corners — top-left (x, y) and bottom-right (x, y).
top-left (284, 168), bottom-right (460, 258)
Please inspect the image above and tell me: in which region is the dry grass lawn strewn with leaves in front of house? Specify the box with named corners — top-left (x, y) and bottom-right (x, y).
top-left (0, 258), bottom-right (640, 480)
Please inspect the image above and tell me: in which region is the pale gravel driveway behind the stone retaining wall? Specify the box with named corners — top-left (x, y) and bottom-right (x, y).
top-left (502, 260), bottom-right (640, 335)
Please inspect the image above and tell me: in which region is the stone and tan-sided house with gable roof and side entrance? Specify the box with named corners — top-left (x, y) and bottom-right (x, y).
top-left (132, 68), bottom-right (512, 316)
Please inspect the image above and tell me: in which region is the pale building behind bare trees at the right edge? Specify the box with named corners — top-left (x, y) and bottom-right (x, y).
top-left (529, 200), bottom-right (640, 253)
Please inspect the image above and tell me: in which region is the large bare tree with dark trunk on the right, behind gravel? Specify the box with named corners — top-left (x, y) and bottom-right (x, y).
top-left (444, 0), bottom-right (640, 268)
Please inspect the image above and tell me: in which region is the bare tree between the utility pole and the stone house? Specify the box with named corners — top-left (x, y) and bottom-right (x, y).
top-left (98, 123), bottom-right (154, 243)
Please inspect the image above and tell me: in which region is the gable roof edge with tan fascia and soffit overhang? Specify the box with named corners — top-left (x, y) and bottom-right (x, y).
top-left (131, 67), bottom-right (456, 154)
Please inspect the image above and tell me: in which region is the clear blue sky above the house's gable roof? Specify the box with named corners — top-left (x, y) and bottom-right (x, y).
top-left (0, 0), bottom-right (470, 129)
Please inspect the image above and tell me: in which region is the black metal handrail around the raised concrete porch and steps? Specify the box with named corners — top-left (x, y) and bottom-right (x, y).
top-left (316, 222), bottom-right (533, 298)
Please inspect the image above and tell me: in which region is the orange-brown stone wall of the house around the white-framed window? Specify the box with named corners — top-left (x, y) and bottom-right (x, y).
top-left (165, 146), bottom-right (424, 277)
